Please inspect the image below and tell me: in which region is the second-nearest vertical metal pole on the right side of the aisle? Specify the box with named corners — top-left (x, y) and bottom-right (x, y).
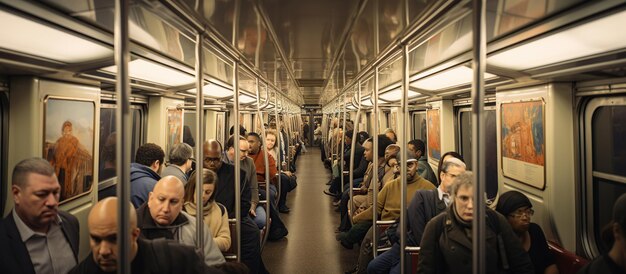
top-left (400, 45), bottom-right (410, 273)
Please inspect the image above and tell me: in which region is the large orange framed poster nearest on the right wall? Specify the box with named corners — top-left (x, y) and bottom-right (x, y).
top-left (500, 100), bottom-right (545, 189)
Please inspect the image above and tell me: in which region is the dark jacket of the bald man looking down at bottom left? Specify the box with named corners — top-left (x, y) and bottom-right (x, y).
top-left (70, 238), bottom-right (222, 274)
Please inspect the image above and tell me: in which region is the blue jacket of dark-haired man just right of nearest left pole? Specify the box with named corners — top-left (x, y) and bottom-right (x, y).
top-left (130, 163), bottom-right (161, 208)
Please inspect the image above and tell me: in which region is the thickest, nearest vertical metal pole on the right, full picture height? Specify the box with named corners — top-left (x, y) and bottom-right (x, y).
top-left (472, 0), bottom-right (487, 274)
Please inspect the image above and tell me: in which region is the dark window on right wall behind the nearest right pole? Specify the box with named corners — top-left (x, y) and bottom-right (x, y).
top-left (458, 108), bottom-right (498, 199)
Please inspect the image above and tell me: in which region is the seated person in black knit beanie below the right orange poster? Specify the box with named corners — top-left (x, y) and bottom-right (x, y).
top-left (496, 190), bottom-right (559, 274)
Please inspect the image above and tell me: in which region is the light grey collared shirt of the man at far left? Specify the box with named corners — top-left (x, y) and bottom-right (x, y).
top-left (13, 209), bottom-right (76, 274)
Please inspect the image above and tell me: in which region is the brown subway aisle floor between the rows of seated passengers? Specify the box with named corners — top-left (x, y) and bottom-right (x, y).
top-left (263, 147), bottom-right (359, 274)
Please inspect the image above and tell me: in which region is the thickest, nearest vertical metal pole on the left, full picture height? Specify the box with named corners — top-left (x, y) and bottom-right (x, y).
top-left (114, 0), bottom-right (133, 274)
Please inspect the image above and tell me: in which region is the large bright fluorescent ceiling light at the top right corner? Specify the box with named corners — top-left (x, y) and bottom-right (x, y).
top-left (487, 11), bottom-right (626, 70)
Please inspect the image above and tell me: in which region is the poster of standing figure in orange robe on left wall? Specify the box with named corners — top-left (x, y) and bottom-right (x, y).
top-left (43, 98), bottom-right (96, 202)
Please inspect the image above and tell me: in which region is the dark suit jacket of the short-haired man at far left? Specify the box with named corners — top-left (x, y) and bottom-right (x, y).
top-left (0, 211), bottom-right (80, 274)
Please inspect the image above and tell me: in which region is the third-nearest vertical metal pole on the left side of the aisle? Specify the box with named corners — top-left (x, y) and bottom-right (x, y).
top-left (233, 62), bottom-right (239, 262)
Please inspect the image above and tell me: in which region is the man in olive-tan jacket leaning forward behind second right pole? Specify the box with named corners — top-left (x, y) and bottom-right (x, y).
top-left (342, 151), bottom-right (435, 273)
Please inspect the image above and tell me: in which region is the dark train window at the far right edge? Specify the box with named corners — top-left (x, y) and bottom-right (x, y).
top-left (587, 103), bottom-right (626, 254)
